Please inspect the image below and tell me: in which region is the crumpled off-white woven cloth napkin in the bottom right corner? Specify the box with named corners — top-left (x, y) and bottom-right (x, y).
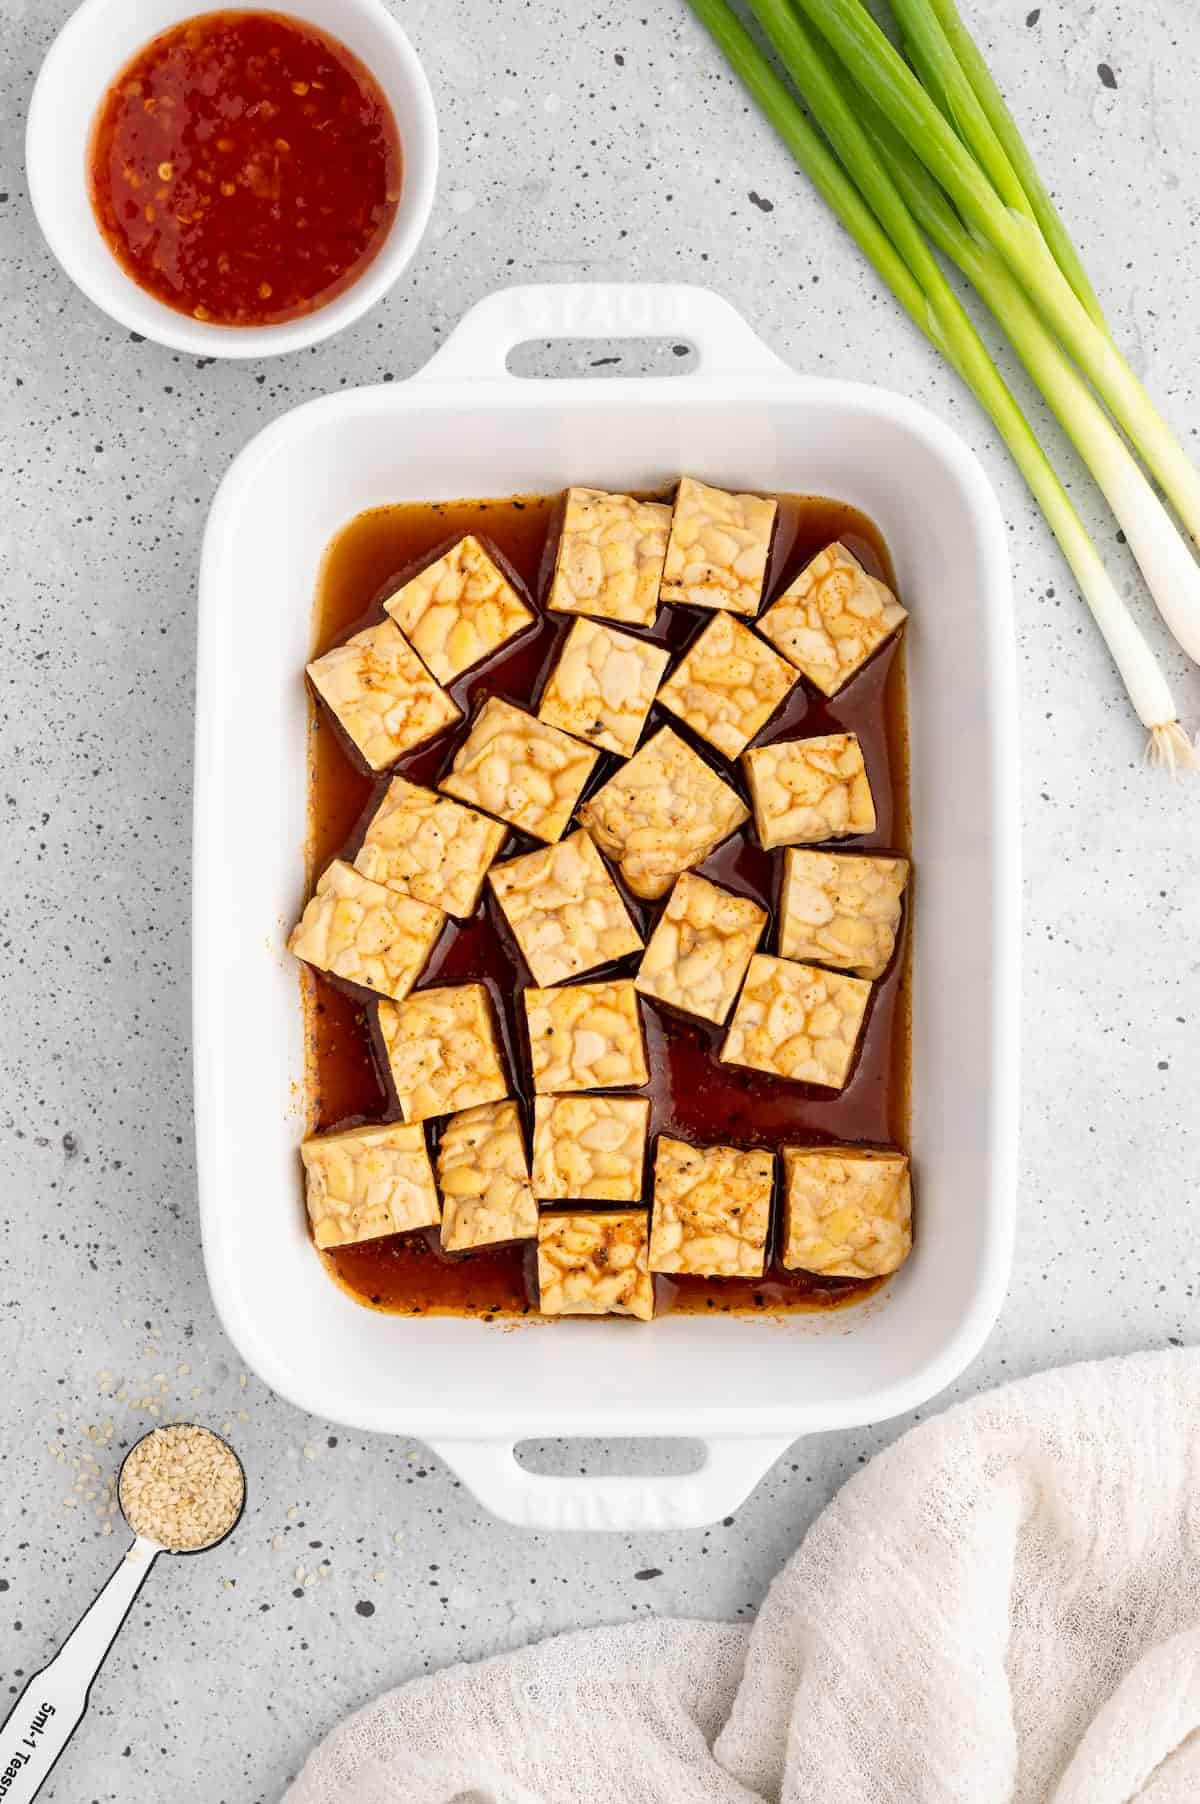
top-left (285, 1351), bottom-right (1200, 1804)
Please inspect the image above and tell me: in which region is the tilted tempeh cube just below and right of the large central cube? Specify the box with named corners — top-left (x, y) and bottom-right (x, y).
top-left (633, 871), bottom-right (767, 1023)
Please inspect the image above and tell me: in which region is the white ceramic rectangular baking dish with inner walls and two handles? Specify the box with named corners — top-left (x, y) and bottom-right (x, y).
top-left (193, 285), bottom-right (1018, 1530)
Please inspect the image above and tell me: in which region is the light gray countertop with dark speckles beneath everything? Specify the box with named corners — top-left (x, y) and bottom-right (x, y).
top-left (0, 0), bottom-right (1200, 1804)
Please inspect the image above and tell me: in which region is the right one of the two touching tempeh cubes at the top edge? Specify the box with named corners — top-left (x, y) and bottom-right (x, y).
top-left (659, 476), bottom-right (776, 613)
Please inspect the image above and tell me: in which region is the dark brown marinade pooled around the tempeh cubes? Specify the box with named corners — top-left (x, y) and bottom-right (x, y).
top-left (301, 494), bottom-right (909, 1319)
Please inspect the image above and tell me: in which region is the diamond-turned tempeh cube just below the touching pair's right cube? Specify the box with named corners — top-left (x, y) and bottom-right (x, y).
top-left (659, 610), bottom-right (798, 758)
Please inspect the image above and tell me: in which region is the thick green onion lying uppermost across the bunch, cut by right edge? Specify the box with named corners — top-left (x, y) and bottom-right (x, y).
top-left (796, 0), bottom-right (1200, 539)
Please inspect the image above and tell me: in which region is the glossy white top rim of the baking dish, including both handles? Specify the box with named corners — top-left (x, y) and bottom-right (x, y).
top-left (193, 283), bottom-right (1020, 1528)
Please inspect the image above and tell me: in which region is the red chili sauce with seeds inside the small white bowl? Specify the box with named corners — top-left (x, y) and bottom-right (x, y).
top-left (88, 13), bottom-right (401, 327)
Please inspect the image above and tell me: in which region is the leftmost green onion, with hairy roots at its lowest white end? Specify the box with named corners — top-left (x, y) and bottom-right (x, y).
top-left (689, 0), bottom-right (1191, 769)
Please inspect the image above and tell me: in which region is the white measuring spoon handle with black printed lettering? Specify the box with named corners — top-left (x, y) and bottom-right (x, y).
top-left (0, 1535), bottom-right (162, 1804)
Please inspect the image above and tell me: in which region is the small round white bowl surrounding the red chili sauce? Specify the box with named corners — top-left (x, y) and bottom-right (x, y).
top-left (25, 0), bottom-right (437, 357)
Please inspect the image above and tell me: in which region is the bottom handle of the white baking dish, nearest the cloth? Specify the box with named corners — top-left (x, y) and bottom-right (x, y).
top-left (429, 1434), bottom-right (790, 1533)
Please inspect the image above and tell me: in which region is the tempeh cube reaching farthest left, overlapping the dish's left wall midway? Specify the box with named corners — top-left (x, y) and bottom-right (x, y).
top-left (287, 859), bottom-right (446, 1001)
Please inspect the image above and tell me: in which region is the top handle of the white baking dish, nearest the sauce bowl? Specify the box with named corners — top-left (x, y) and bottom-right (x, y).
top-left (413, 281), bottom-right (789, 382)
